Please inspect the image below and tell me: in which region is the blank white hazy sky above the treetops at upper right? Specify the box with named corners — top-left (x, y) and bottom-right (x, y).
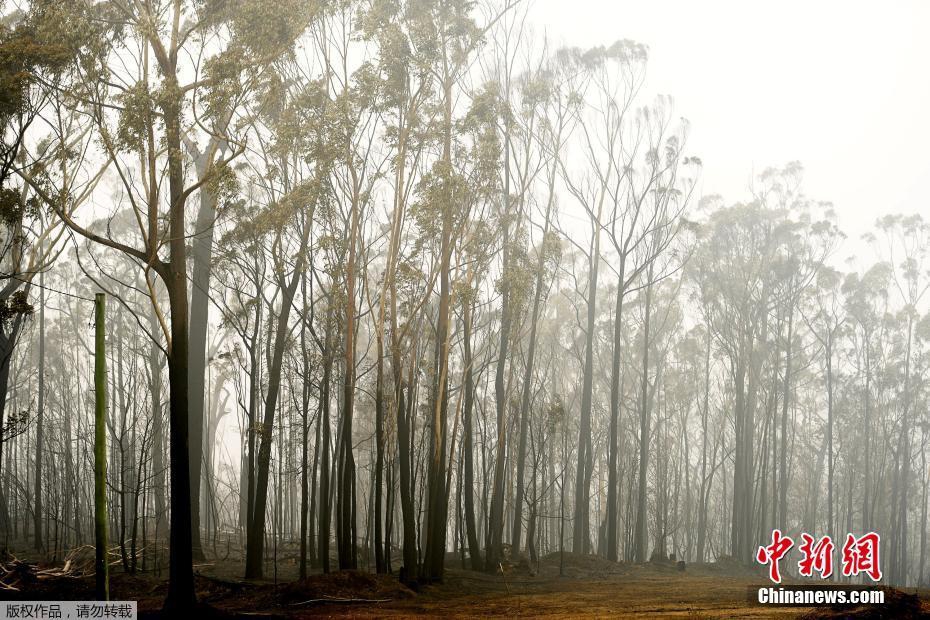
top-left (530, 0), bottom-right (930, 253)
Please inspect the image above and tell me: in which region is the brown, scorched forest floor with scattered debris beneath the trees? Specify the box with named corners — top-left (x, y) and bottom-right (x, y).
top-left (0, 553), bottom-right (930, 620)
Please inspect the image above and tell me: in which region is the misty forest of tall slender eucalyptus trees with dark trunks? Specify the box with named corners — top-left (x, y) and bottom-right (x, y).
top-left (0, 0), bottom-right (930, 610)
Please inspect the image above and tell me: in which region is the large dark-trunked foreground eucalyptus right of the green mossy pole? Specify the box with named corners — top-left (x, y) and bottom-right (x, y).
top-left (20, 0), bottom-right (313, 609)
